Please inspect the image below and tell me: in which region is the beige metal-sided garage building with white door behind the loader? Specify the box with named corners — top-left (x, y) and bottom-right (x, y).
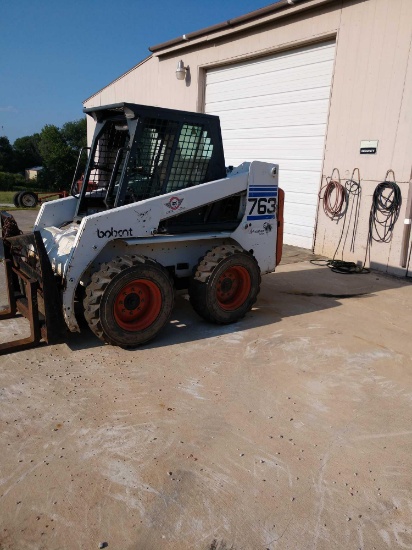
top-left (85, 0), bottom-right (412, 277)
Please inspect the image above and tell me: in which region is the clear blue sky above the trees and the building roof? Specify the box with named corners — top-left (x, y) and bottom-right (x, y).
top-left (0, 0), bottom-right (275, 143)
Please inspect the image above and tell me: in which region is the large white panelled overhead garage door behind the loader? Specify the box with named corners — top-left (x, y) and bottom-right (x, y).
top-left (205, 41), bottom-right (335, 248)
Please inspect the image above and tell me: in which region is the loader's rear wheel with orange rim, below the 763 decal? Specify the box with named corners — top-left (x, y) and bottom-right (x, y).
top-left (189, 245), bottom-right (261, 324)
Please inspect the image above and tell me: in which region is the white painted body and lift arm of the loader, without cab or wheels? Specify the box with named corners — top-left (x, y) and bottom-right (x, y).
top-left (34, 161), bottom-right (279, 331)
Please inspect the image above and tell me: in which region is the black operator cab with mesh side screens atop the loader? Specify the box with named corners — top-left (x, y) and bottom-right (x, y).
top-left (71, 103), bottom-right (226, 217)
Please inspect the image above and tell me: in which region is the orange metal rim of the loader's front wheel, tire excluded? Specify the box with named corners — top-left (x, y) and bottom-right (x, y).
top-left (114, 279), bottom-right (162, 331)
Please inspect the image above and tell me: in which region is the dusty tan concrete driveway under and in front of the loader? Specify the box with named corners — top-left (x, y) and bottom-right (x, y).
top-left (0, 209), bottom-right (412, 550)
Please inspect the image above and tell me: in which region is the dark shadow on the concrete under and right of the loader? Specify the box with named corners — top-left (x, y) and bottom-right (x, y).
top-left (63, 263), bottom-right (408, 352)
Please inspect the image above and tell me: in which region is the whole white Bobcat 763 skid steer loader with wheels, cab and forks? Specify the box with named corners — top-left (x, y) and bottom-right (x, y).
top-left (0, 103), bottom-right (283, 354)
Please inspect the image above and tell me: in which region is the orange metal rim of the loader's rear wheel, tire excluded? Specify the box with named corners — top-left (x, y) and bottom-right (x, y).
top-left (216, 266), bottom-right (252, 311)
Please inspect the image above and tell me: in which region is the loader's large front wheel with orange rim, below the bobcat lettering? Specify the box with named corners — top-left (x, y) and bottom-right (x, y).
top-left (83, 256), bottom-right (174, 347)
